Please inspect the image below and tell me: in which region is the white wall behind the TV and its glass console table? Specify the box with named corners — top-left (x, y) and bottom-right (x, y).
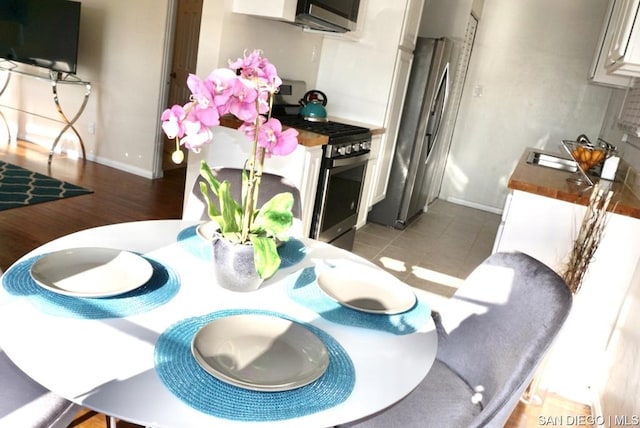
top-left (2, 0), bottom-right (169, 177)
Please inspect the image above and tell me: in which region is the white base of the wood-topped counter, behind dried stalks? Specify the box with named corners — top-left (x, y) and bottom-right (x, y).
top-left (494, 190), bottom-right (640, 403)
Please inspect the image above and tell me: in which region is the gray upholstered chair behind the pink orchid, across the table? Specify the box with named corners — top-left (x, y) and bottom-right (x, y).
top-left (182, 167), bottom-right (301, 234)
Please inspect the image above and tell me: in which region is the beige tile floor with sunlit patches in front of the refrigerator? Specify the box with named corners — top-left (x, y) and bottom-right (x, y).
top-left (353, 200), bottom-right (500, 309)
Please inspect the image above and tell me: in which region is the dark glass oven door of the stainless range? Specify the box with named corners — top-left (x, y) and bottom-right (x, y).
top-left (311, 152), bottom-right (369, 249)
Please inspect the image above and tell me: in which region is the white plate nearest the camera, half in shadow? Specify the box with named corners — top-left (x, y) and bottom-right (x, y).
top-left (191, 314), bottom-right (329, 391)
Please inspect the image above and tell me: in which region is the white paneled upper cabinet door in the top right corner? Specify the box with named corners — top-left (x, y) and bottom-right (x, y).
top-left (607, 0), bottom-right (640, 77)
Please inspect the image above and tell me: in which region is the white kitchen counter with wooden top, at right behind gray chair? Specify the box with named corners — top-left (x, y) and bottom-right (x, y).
top-left (494, 149), bottom-right (640, 404)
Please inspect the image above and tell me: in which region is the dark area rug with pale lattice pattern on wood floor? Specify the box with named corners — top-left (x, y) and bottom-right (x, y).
top-left (0, 161), bottom-right (93, 211)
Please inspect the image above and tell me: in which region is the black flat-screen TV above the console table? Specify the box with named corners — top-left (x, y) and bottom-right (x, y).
top-left (0, 0), bottom-right (80, 74)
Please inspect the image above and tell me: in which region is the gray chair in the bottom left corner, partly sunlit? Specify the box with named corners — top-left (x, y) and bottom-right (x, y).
top-left (0, 350), bottom-right (81, 428)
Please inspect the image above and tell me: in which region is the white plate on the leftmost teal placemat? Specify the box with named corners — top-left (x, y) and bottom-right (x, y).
top-left (30, 247), bottom-right (153, 297)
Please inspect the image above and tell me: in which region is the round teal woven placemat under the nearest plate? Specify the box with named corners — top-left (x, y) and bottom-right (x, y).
top-left (155, 309), bottom-right (355, 421)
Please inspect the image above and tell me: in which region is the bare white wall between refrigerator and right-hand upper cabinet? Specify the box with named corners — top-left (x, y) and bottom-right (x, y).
top-left (440, 0), bottom-right (611, 211)
